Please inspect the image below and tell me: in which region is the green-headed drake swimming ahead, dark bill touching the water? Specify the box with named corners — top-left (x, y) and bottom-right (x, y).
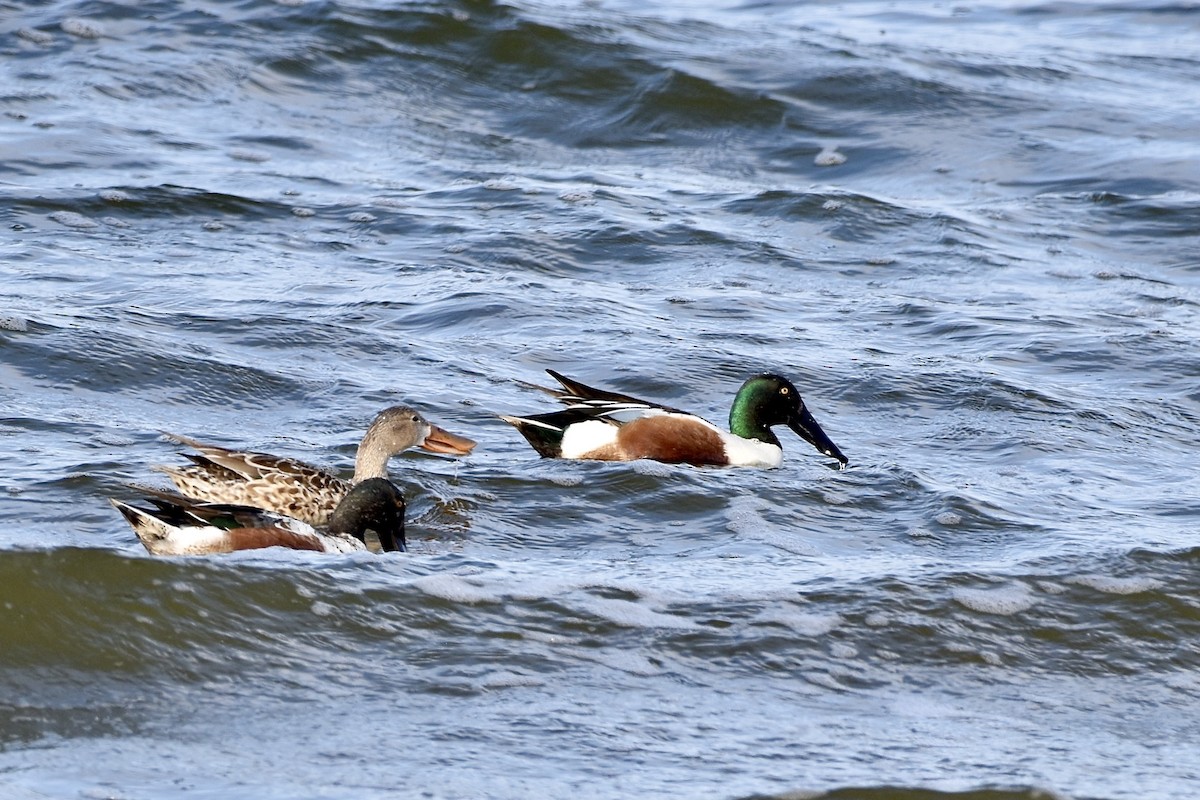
top-left (500, 369), bottom-right (848, 468)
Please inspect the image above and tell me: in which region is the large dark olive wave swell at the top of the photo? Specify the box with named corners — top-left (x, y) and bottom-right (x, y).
top-left (261, 6), bottom-right (782, 148)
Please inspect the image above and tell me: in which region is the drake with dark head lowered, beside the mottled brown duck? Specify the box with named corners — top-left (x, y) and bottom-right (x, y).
top-left (109, 477), bottom-right (407, 555)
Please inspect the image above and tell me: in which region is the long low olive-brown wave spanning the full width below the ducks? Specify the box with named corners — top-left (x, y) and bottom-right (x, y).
top-left (0, 549), bottom-right (1200, 685)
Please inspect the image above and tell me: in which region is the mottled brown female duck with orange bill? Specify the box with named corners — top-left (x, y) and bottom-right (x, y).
top-left (155, 405), bottom-right (475, 525)
